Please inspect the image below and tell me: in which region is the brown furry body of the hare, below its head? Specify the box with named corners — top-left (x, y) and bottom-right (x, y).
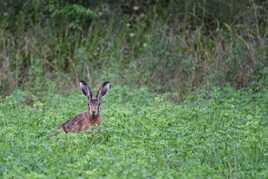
top-left (59, 112), bottom-right (101, 133)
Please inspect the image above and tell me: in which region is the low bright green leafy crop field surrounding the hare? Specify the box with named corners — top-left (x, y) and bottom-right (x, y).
top-left (0, 87), bottom-right (268, 178)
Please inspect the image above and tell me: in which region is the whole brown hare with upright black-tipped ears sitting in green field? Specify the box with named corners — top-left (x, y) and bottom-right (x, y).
top-left (59, 81), bottom-right (111, 133)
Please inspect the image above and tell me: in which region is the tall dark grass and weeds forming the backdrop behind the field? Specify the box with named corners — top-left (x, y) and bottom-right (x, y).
top-left (0, 0), bottom-right (268, 100)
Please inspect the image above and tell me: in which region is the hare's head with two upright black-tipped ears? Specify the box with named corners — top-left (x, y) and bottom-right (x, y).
top-left (80, 81), bottom-right (111, 117)
